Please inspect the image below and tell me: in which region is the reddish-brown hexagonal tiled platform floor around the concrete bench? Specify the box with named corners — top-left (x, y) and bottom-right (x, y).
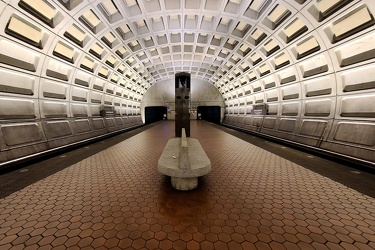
top-left (0, 122), bottom-right (375, 250)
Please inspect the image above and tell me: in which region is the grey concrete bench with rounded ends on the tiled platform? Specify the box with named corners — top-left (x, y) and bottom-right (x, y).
top-left (158, 128), bottom-right (211, 190)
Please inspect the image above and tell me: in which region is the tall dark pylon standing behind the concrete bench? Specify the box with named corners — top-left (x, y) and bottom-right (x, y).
top-left (175, 72), bottom-right (190, 137)
